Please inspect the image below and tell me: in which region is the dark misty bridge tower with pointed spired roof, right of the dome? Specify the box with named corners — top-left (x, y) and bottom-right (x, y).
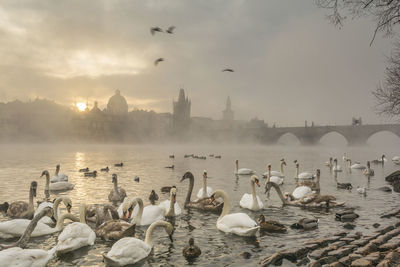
top-left (172, 89), bottom-right (191, 131)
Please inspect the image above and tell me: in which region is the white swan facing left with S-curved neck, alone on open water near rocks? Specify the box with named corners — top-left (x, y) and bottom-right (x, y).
top-left (210, 190), bottom-right (260, 236)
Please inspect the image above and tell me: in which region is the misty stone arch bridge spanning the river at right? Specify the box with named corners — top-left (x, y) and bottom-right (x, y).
top-left (255, 124), bottom-right (400, 145)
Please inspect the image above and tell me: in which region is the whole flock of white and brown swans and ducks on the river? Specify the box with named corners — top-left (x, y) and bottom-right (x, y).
top-left (0, 154), bottom-right (400, 266)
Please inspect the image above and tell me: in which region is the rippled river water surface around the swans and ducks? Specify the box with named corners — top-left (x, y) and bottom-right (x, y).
top-left (0, 145), bottom-right (400, 266)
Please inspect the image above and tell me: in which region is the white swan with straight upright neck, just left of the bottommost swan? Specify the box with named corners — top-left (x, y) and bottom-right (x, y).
top-left (56, 204), bottom-right (96, 254)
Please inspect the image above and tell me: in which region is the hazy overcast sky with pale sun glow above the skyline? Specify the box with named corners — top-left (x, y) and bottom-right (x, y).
top-left (0, 0), bottom-right (393, 125)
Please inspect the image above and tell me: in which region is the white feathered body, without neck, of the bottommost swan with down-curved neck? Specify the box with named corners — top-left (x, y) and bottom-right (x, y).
top-left (107, 237), bottom-right (151, 266)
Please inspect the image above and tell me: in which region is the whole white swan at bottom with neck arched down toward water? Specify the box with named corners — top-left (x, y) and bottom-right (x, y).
top-left (103, 221), bottom-right (174, 266)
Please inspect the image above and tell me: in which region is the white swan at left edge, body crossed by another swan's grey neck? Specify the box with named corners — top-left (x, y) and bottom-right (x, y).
top-left (0, 210), bottom-right (77, 239)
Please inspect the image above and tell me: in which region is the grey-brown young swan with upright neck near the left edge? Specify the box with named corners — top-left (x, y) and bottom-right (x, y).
top-left (7, 181), bottom-right (37, 219)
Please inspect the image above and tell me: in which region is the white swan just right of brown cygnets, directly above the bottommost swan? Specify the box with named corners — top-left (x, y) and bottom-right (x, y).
top-left (131, 198), bottom-right (165, 225)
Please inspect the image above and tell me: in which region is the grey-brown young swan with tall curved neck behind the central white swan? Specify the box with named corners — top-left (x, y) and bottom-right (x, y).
top-left (180, 172), bottom-right (224, 214)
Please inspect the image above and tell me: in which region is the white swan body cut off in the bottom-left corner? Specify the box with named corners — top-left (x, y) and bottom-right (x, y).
top-left (0, 247), bottom-right (56, 267)
